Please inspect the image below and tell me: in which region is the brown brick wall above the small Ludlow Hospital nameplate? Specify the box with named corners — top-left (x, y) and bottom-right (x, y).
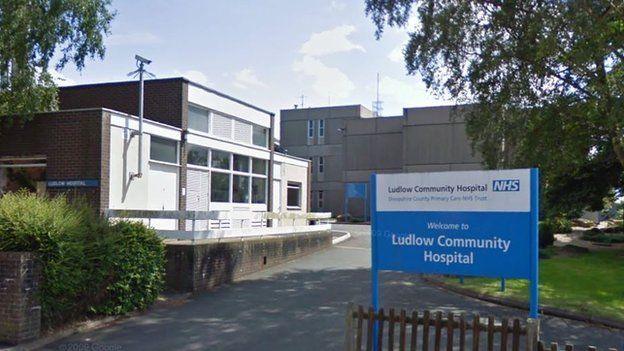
top-left (0, 108), bottom-right (110, 209)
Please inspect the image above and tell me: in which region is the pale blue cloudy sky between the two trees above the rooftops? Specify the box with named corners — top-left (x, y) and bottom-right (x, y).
top-left (56, 0), bottom-right (450, 116)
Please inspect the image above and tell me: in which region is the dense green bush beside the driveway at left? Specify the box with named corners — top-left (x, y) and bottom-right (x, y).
top-left (0, 192), bottom-right (164, 326)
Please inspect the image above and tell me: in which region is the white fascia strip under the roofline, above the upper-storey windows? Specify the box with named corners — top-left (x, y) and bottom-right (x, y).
top-left (188, 84), bottom-right (271, 128)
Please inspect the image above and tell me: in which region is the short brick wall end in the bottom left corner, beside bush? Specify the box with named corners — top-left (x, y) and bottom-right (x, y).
top-left (0, 252), bottom-right (41, 344)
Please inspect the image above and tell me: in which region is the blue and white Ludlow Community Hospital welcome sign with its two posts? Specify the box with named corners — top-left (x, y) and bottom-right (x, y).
top-left (370, 169), bottom-right (539, 346)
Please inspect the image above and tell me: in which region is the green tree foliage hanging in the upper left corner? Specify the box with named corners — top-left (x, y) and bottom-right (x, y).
top-left (0, 0), bottom-right (115, 118)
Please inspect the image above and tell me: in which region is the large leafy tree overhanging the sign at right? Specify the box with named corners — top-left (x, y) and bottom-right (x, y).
top-left (366, 0), bottom-right (624, 217)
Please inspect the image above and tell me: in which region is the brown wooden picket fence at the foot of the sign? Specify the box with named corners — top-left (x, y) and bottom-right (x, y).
top-left (345, 304), bottom-right (617, 351)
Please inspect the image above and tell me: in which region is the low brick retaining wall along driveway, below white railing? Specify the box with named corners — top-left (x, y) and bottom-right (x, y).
top-left (166, 231), bottom-right (332, 292)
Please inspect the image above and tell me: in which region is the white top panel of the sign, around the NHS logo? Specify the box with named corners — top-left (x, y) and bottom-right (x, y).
top-left (377, 169), bottom-right (531, 212)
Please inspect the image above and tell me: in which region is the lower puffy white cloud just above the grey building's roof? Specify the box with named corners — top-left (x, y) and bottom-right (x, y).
top-left (292, 56), bottom-right (355, 99)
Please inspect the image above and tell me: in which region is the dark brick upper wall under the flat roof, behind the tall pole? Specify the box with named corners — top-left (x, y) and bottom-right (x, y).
top-left (59, 78), bottom-right (187, 128)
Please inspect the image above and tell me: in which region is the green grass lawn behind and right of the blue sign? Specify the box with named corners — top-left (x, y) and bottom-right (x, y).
top-left (444, 251), bottom-right (624, 321)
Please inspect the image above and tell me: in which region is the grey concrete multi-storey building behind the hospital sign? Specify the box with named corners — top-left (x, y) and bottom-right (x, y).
top-left (280, 105), bottom-right (483, 219)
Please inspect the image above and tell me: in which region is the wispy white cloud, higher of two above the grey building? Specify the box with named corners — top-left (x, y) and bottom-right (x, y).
top-left (299, 24), bottom-right (366, 57)
